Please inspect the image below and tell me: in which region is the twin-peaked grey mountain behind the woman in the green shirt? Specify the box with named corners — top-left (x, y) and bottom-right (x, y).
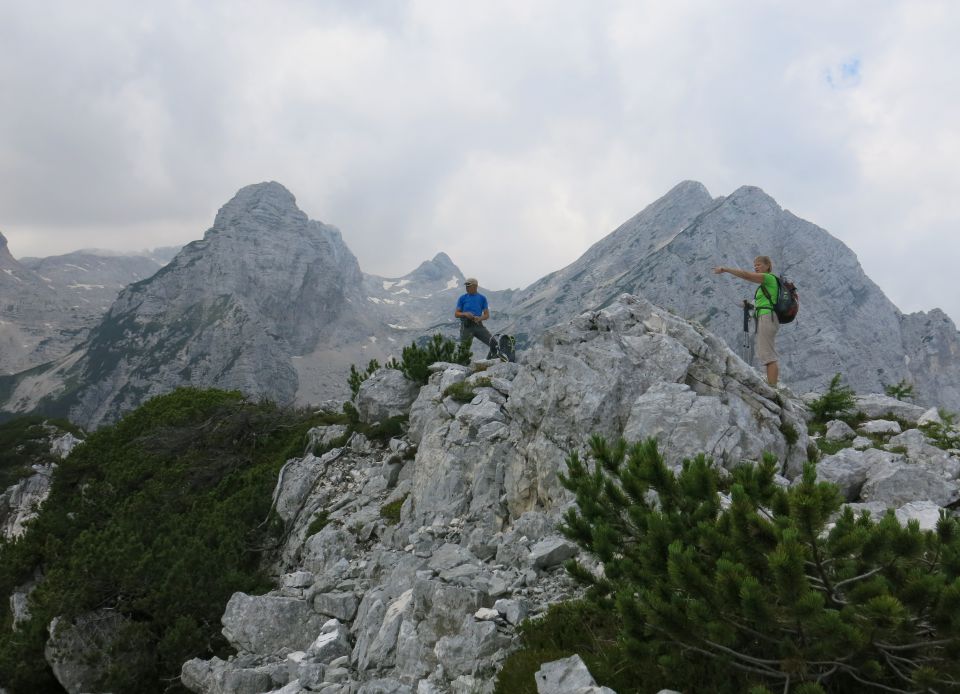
top-left (498, 181), bottom-right (960, 409)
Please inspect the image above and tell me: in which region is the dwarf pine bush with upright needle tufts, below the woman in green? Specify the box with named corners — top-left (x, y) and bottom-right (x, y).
top-left (561, 437), bottom-right (960, 693)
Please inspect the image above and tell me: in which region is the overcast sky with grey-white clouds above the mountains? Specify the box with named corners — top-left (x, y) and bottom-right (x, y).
top-left (0, 0), bottom-right (960, 322)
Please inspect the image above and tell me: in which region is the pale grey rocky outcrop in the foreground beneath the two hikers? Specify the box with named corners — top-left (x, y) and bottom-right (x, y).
top-left (176, 296), bottom-right (806, 694)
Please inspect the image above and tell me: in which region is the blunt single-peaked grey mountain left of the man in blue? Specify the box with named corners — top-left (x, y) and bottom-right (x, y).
top-left (6, 183), bottom-right (372, 427)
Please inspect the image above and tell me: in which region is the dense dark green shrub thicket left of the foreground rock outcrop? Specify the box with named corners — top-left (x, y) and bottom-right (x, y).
top-left (0, 388), bottom-right (328, 693)
